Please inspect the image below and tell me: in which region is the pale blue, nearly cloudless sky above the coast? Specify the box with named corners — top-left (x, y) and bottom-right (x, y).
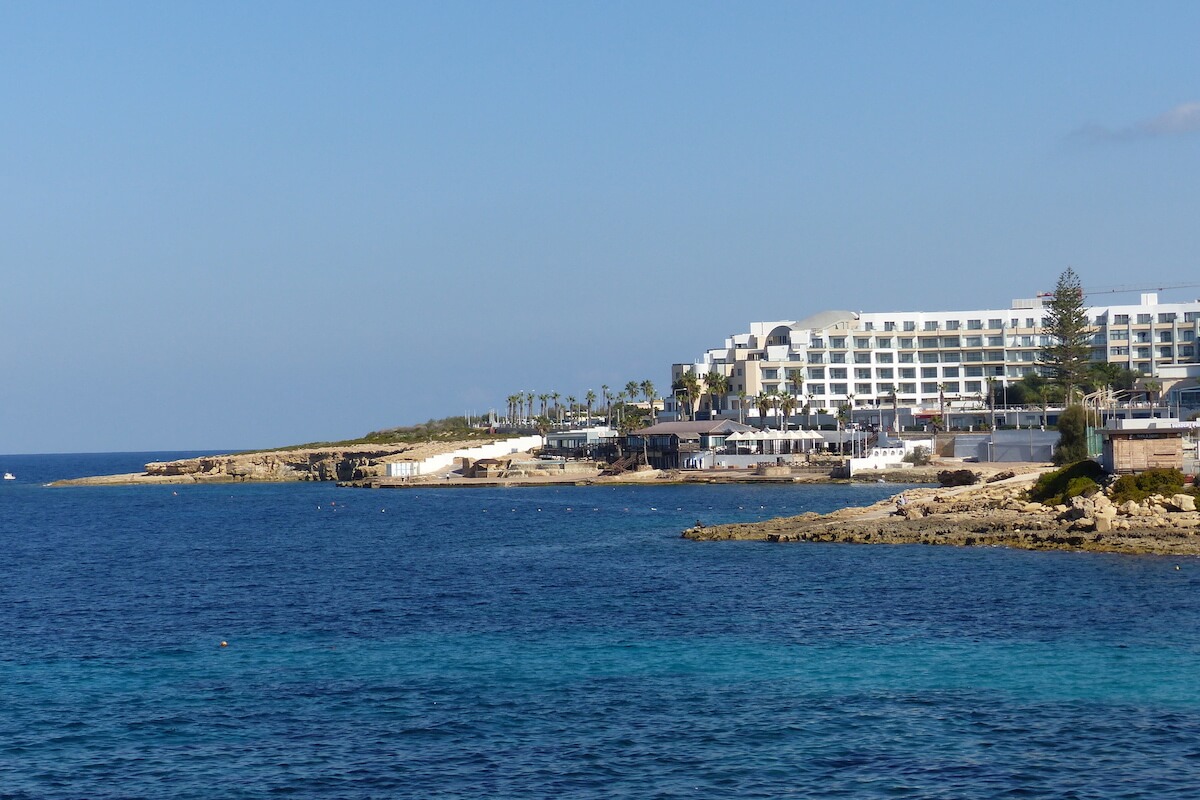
top-left (0, 0), bottom-right (1200, 452)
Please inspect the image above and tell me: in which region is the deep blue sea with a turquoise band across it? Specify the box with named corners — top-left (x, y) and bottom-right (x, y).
top-left (0, 453), bottom-right (1200, 799)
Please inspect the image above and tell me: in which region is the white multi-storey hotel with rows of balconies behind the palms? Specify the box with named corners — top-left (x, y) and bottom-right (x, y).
top-left (671, 294), bottom-right (1200, 419)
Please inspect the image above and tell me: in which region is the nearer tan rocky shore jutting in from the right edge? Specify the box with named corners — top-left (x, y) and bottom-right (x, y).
top-left (683, 473), bottom-right (1200, 555)
